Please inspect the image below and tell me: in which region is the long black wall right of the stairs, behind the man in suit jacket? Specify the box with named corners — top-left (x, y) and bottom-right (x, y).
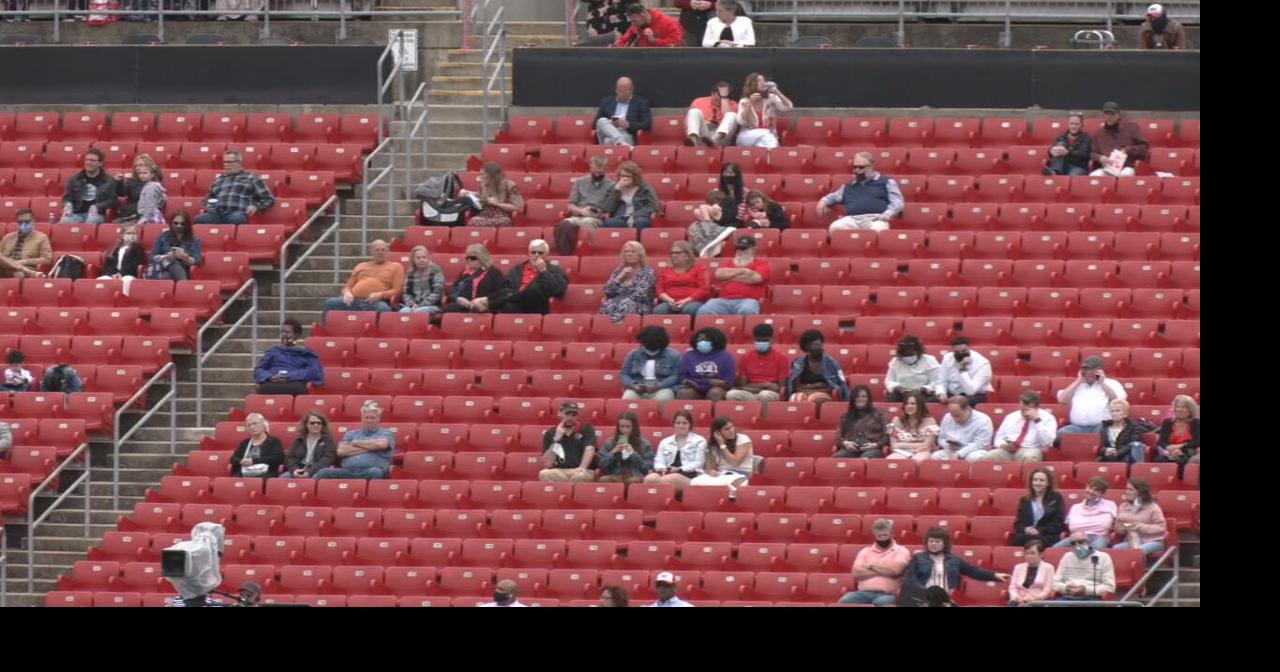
top-left (513, 47), bottom-right (1201, 111)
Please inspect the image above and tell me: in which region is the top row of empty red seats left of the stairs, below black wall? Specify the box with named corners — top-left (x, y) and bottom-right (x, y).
top-left (0, 111), bottom-right (387, 151)
